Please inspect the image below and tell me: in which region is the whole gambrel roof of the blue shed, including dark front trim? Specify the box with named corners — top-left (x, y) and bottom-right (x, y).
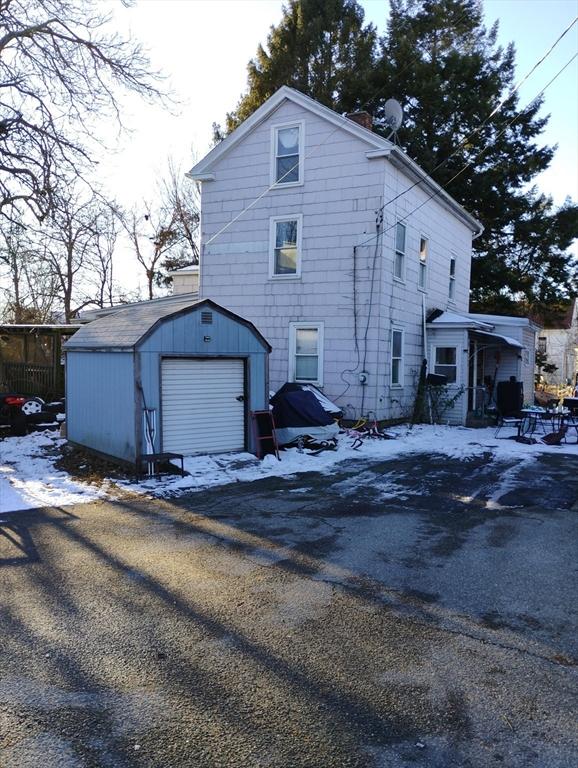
top-left (64, 294), bottom-right (271, 351)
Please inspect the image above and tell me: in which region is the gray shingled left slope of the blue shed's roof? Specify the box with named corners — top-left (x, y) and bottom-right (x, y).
top-left (64, 294), bottom-right (203, 350)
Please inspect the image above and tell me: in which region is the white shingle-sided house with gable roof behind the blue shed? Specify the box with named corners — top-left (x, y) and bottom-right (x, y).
top-left (189, 87), bottom-right (533, 422)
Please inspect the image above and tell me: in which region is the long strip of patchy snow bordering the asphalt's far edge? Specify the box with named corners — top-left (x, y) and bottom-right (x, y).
top-left (0, 426), bottom-right (578, 513)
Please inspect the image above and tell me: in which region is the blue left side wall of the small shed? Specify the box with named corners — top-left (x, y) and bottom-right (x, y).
top-left (66, 351), bottom-right (136, 462)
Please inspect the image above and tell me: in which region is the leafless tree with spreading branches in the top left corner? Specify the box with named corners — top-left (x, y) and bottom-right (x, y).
top-left (0, 0), bottom-right (161, 220)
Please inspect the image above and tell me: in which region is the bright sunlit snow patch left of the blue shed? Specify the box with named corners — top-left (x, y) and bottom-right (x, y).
top-left (0, 432), bottom-right (106, 513)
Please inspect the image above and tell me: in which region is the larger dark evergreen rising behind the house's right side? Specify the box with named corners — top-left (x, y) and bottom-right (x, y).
top-left (372, 0), bottom-right (578, 311)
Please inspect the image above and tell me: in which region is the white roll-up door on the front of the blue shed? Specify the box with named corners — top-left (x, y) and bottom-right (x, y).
top-left (162, 360), bottom-right (245, 456)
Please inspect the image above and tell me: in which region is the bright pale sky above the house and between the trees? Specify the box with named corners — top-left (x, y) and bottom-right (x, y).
top-left (100, 0), bottom-right (578, 296)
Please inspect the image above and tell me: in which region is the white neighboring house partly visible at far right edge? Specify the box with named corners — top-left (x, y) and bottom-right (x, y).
top-left (538, 299), bottom-right (578, 386)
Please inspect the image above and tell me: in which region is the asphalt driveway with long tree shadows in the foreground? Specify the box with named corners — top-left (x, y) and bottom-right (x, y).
top-left (0, 454), bottom-right (578, 768)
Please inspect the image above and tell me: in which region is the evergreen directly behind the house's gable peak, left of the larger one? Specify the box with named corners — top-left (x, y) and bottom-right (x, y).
top-left (223, 0), bottom-right (377, 132)
